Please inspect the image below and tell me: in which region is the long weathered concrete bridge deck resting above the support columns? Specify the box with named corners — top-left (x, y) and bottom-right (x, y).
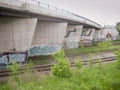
top-left (0, 0), bottom-right (101, 28)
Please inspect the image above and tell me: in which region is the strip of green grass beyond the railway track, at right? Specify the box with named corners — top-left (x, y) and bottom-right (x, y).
top-left (65, 42), bottom-right (120, 55)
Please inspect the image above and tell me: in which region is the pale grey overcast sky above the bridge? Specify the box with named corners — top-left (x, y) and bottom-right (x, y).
top-left (37, 0), bottom-right (120, 26)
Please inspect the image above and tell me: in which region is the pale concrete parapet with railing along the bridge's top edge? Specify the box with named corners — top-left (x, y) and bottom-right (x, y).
top-left (18, 0), bottom-right (101, 28)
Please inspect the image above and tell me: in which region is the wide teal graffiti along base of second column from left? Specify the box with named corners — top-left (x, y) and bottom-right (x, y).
top-left (28, 45), bottom-right (62, 56)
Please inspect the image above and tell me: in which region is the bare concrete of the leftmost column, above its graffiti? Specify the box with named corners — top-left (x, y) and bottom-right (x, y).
top-left (0, 17), bottom-right (37, 52)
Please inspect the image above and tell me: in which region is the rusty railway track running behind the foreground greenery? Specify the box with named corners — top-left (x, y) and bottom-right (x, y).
top-left (0, 57), bottom-right (117, 78)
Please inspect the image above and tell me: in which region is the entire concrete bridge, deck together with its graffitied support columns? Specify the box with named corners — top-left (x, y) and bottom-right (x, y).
top-left (0, 0), bottom-right (101, 56)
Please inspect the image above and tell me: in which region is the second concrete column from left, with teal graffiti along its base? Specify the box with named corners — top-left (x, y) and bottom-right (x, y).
top-left (29, 20), bottom-right (67, 56)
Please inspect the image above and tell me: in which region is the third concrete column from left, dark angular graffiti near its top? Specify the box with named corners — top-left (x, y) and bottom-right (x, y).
top-left (65, 25), bottom-right (83, 49)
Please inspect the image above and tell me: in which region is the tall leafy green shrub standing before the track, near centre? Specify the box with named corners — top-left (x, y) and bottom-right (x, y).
top-left (52, 50), bottom-right (71, 77)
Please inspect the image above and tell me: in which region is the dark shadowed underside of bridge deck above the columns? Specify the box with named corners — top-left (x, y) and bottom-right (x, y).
top-left (0, 8), bottom-right (99, 29)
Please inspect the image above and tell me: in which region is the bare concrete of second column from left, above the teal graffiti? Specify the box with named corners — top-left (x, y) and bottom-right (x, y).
top-left (32, 20), bottom-right (67, 46)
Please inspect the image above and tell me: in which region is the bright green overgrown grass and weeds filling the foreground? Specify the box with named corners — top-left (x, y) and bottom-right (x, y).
top-left (0, 52), bottom-right (120, 90)
